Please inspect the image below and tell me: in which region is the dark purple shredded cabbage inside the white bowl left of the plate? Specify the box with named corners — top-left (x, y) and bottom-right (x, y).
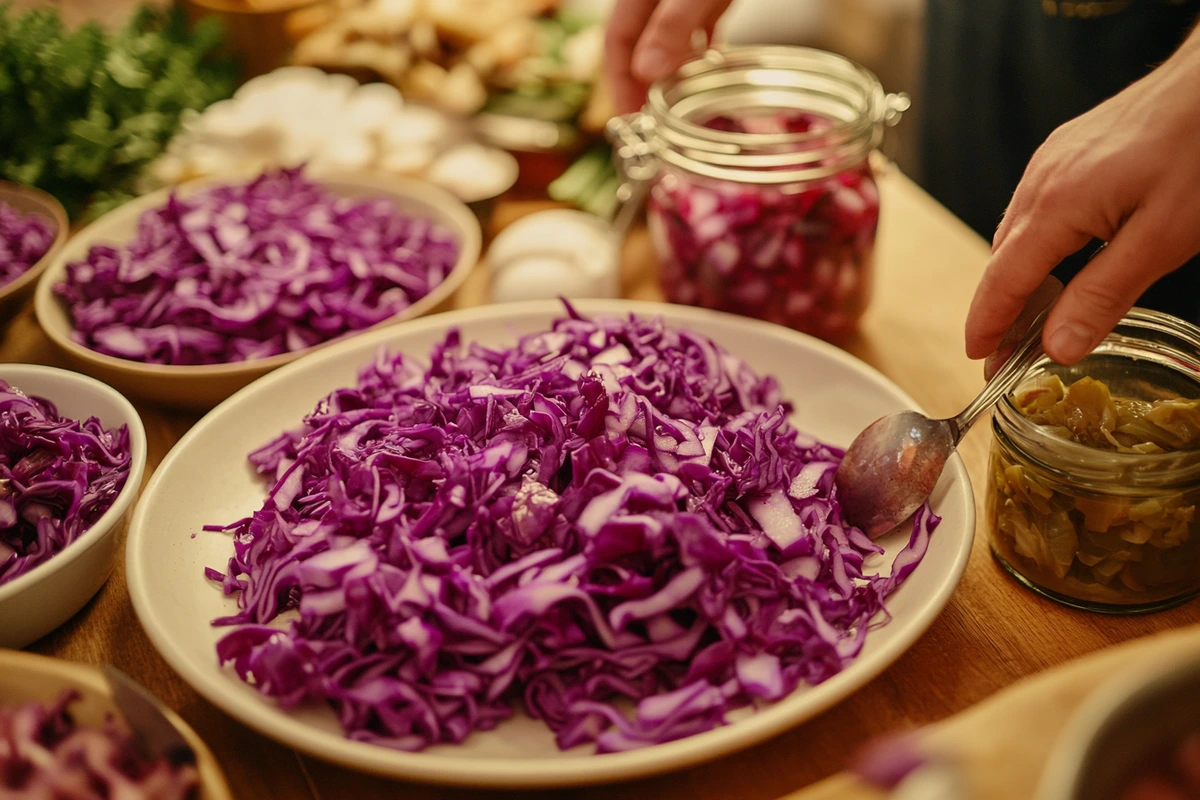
top-left (0, 380), bottom-right (131, 585)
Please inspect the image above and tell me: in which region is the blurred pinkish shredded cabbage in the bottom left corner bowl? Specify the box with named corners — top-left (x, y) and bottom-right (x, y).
top-left (0, 691), bottom-right (199, 800)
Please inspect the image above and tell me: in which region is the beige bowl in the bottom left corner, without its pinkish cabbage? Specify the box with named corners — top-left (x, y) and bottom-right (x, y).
top-left (0, 650), bottom-right (233, 800)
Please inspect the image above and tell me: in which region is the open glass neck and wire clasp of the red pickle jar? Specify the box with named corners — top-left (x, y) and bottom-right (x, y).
top-left (616, 46), bottom-right (910, 185)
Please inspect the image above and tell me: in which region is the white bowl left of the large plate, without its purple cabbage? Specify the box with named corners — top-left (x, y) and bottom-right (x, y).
top-left (0, 363), bottom-right (146, 648)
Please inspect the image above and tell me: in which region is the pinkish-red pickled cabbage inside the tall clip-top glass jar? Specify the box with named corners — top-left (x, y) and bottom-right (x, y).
top-left (648, 112), bottom-right (880, 341)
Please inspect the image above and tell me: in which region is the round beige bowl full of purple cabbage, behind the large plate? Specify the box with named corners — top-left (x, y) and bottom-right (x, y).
top-left (35, 168), bottom-right (481, 409)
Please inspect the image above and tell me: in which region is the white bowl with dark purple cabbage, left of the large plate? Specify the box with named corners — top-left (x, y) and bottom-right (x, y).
top-left (0, 363), bottom-right (146, 648)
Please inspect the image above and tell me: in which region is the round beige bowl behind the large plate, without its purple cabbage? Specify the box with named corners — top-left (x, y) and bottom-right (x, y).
top-left (34, 175), bottom-right (481, 410)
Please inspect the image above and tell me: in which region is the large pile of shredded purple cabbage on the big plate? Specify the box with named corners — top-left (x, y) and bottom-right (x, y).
top-left (206, 311), bottom-right (938, 752)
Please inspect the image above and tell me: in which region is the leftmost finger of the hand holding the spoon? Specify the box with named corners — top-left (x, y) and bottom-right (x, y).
top-left (966, 213), bottom-right (1092, 359)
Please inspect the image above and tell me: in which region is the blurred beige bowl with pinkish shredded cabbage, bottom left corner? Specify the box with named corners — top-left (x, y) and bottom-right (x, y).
top-left (0, 651), bottom-right (233, 800)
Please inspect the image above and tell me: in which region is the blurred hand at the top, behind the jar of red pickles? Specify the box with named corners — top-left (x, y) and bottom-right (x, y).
top-left (605, 0), bottom-right (732, 114)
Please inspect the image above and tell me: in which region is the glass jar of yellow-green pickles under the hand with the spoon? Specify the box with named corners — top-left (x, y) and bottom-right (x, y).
top-left (984, 308), bottom-right (1200, 613)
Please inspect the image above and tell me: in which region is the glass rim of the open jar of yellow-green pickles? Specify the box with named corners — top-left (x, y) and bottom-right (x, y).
top-left (992, 308), bottom-right (1200, 488)
